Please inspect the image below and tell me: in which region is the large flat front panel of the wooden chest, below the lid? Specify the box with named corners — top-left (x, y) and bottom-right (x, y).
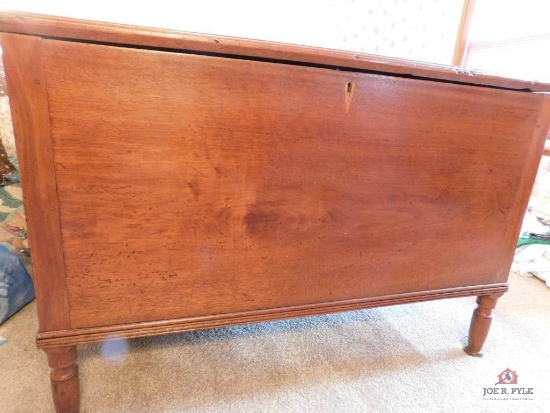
top-left (38, 40), bottom-right (543, 328)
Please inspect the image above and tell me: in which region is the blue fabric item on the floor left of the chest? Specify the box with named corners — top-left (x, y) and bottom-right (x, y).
top-left (0, 245), bottom-right (34, 324)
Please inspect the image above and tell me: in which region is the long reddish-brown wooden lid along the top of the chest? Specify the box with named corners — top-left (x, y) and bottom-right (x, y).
top-left (0, 11), bottom-right (550, 92)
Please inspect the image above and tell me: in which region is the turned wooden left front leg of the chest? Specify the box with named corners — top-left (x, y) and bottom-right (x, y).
top-left (45, 346), bottom-right (80, 413)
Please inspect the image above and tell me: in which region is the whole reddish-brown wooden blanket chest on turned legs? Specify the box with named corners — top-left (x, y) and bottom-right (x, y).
top-left (0, 13), bottom-right (550, 411)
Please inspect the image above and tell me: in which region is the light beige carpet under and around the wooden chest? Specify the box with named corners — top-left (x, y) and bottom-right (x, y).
top-left (0, 275), bottom-right (550, 413)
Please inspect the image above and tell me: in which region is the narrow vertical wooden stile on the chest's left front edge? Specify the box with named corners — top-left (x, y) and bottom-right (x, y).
top-left (0, 33), bottom-right (70, 331)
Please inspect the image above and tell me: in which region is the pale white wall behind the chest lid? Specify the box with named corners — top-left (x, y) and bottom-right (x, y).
top-left (0, 0), bottom-right (463, 64)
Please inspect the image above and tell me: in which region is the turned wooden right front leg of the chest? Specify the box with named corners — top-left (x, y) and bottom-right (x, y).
top-left (464, 293), bottom-right (502, 357)
